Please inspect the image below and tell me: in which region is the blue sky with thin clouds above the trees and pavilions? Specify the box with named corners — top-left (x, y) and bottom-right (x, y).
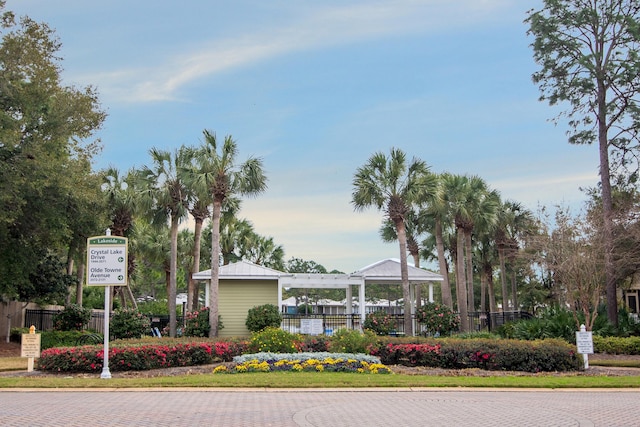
top-left (7, 0), bottom-right (598, 272)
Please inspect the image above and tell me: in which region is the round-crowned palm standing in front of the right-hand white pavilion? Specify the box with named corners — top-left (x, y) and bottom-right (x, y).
top-left (352, 148), bottom-right (437, 335)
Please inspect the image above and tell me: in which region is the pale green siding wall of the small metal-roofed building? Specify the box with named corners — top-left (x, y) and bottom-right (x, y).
top-left (218, 280), bottom-right (278, 337)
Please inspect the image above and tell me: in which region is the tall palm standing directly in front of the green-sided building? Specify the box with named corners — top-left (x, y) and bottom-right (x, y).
top-left (191, 130), bottom-right (267, 337)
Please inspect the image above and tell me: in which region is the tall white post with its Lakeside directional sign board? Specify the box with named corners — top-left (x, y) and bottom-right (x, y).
top-left (87, 229), bottom-right (129, 379)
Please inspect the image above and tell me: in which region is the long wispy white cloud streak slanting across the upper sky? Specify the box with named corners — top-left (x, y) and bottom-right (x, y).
top-left (87, 0), bottom-right (513, 102)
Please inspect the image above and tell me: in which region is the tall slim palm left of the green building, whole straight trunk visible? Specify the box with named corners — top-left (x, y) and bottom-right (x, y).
top-left (141, 146), bottom-right (193, 337)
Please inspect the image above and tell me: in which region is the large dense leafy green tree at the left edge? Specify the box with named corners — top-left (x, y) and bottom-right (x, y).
top-left (0, 3), bottom-right (105, 301)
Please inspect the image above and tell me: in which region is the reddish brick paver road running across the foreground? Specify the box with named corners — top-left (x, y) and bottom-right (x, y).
top-left (0, 388), bottom-right (640, 427)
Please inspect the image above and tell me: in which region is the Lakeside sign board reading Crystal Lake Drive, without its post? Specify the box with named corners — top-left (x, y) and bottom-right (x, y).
top-left (87, 236), bottom-right (129, 286)
